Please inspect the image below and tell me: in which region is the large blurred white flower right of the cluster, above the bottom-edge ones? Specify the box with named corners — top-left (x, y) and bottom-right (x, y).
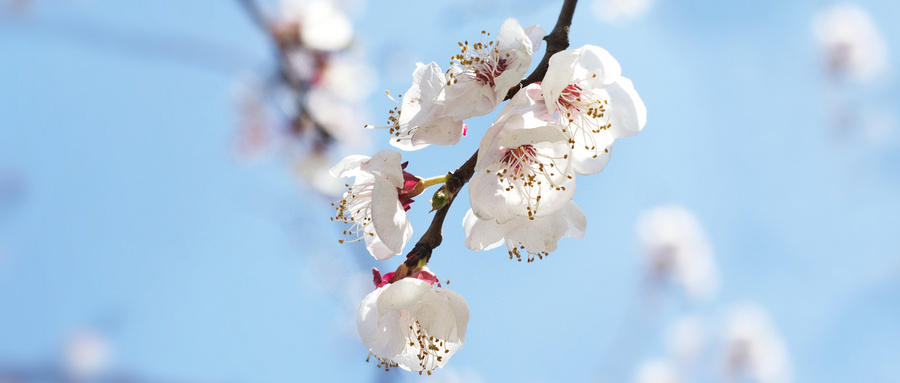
top-left (637, 206), bottom-right (719, 299)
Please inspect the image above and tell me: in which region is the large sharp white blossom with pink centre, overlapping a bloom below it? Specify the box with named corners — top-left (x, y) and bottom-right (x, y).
top-left (469, 84), bottom-right (575, 223)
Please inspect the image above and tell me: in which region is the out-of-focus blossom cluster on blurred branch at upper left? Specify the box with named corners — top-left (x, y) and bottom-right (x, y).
top-left (238, 0), bottom-right (373, 195)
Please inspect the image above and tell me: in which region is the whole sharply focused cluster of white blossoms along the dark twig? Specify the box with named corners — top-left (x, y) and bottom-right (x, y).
top-left (331, 15), bottom-right (646, 374)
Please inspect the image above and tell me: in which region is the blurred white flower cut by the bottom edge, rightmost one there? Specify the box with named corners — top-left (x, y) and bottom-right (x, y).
top-left (722, 304), bottom-right (791, 383)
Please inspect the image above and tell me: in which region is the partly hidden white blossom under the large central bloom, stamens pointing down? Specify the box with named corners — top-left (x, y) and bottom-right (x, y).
top-left (463, 201), bottom-right (587, 262)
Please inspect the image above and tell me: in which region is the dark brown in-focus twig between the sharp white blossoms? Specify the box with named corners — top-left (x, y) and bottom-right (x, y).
top-left (390, 0), bottom-right (578, 283)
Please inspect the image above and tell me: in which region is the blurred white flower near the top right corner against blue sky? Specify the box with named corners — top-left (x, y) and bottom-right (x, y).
top-left (812, 3), bottom-right (888, 82)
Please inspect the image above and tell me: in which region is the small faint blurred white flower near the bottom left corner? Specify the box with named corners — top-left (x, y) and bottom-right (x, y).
top-left (63, 329), bottom-right (110, 380)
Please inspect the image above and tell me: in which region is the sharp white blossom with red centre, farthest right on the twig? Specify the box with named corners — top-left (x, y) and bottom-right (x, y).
top-left (541, 45), bottom-right (647, 174)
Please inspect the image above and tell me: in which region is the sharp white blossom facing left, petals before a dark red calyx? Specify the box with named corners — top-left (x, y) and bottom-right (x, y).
top-left (331, 149), bottom-right (412, 260)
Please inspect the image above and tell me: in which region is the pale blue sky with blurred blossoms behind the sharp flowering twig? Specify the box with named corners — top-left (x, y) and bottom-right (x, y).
top-left (0, 0), bottom-right (900, 383)
